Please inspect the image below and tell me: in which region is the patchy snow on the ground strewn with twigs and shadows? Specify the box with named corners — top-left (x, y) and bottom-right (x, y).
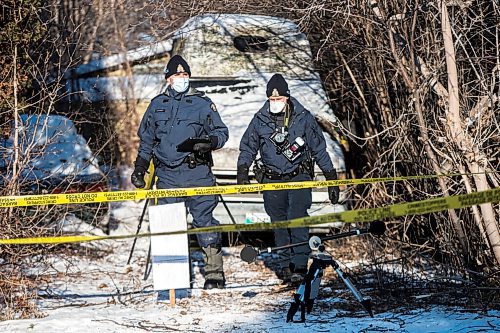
top-left (0, 202), bottom-right (500, 333)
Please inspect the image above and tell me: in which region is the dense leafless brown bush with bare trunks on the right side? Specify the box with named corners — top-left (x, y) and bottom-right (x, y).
top-left (290, 1), bottom-right (500, 271)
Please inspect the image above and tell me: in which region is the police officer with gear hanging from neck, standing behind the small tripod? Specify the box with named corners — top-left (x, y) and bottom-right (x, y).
top-left (237, 74), bottom-right (339, 283)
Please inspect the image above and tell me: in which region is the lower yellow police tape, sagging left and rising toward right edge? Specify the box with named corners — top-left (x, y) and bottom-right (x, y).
top-left (0, 188), bottom-right (500, 244)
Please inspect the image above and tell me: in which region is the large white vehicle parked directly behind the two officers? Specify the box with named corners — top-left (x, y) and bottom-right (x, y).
top-left (66, 14), bottom-right (347, 230)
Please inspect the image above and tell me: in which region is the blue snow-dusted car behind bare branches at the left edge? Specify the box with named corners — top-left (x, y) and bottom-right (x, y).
top-left (0, 114), bottom-right (109, 228)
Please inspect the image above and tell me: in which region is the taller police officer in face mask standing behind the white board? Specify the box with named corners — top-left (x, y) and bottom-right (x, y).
top-left (131, 55), bottom-right (229, 289)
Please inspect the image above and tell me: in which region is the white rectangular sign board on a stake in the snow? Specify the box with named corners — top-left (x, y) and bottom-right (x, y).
top-left (149, 202), bottom-right (190, 290)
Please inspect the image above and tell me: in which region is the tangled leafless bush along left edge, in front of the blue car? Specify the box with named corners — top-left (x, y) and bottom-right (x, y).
top-left (0, 1), bottom-right (111, 319)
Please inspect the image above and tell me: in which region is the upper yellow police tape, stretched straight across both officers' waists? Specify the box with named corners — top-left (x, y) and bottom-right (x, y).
top-left (0, 173), bottom-right (494, 208)
